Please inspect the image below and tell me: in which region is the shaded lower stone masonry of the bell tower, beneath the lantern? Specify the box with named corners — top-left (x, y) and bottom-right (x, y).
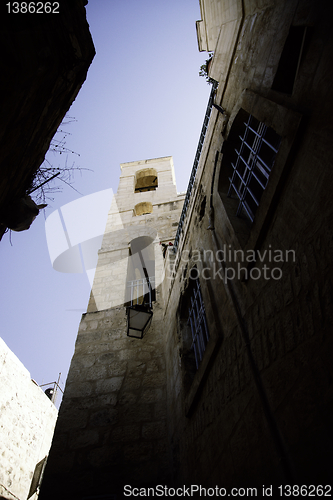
top-left (41, 304), bottom-right (170, 499)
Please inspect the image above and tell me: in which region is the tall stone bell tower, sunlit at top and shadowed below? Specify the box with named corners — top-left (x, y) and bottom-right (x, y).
top-left (41, 157), bottom-right (184, 500)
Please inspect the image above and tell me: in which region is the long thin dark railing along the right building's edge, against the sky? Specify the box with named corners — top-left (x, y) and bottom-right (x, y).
top-left (174, 80), bottom-right (218, 252)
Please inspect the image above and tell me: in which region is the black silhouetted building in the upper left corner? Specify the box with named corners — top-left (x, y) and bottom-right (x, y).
top-left (0, 0), bottom-right (95, 239)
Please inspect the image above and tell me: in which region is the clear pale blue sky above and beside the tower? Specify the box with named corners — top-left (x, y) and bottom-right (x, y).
top-left (0, 0), bottom-right (210, 402)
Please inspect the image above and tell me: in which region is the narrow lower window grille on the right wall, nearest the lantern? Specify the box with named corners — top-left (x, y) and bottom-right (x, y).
top-left (188, 279), bottom-right (209, 369)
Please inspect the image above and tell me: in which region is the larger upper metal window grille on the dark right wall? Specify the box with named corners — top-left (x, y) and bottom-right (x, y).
top-left (228, 115), bottom-right (281, 222)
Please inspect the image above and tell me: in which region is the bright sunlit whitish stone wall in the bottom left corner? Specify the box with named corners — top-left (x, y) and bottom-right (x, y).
top-left (0, 339), bottom-right (58, 500)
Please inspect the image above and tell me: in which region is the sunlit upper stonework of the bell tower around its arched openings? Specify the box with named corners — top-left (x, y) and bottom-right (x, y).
top-left (87, 156), bottom-right (184, 312)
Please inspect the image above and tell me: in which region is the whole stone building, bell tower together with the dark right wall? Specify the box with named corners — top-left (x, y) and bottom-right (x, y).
top-left (42, 0), bottom-right (333, 499)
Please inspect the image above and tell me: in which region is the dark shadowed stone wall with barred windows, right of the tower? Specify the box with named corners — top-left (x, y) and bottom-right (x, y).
top-left (165, 2), bottom-right (333, 488)
